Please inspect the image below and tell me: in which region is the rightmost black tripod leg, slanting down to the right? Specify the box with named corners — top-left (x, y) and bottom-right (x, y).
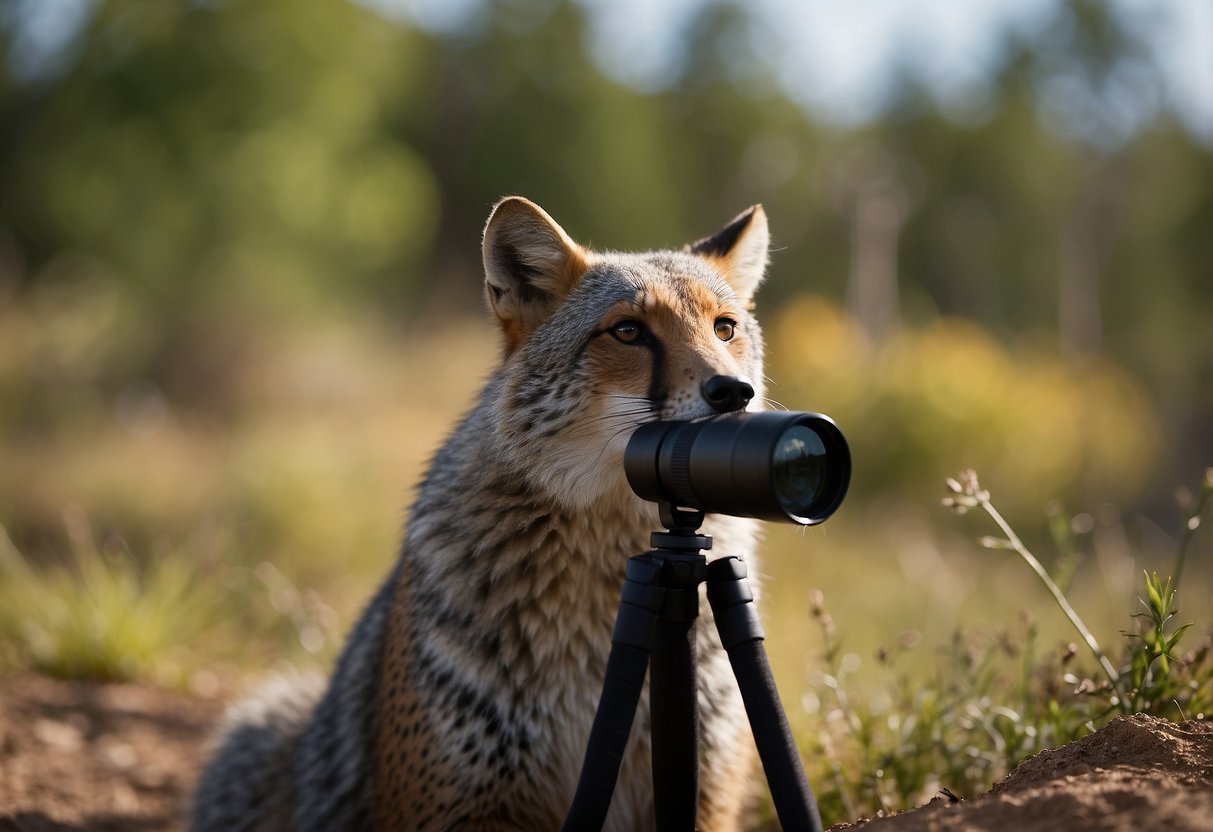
top-left (707, 557), bottom-right (821, 832)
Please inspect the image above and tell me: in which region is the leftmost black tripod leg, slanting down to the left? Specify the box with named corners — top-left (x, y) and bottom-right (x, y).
top-left (560, 557), bottom-right (665, 832)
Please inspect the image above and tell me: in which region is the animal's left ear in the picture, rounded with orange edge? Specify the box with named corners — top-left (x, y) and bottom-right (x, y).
top-left (480, 196), bottom-right (590, 355)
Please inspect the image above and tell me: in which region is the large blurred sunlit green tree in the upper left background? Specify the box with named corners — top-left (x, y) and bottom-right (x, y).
top-left (0, 0), bottom-right (438, 310)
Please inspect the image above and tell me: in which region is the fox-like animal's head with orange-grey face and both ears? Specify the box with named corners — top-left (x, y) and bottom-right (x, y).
top-left (483, 196), bottom-right (769, 508)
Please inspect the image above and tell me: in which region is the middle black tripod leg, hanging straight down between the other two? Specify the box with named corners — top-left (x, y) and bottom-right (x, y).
top-left (649, 606), bottom-right (699, 832)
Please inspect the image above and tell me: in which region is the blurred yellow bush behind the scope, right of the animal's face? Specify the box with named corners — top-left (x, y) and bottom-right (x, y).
top-left (769, 297), bottom-right (1160, 505)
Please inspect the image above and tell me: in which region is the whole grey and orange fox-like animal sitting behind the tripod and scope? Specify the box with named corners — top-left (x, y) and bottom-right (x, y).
top-left (193, 198), bottom-right (768, 832)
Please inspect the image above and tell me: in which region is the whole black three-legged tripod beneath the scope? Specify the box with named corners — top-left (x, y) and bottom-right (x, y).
top-left (562, 503), bottom-right (821, 832)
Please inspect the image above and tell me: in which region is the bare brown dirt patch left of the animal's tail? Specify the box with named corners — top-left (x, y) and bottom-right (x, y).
top-left (0, 674), bottom-right (222, 832)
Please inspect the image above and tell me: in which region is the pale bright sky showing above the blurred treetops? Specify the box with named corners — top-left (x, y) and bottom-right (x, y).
top-left (9, 0), bottom-right (1213, 147)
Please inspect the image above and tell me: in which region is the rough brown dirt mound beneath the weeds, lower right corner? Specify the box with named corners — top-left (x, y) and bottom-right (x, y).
top-left (833, 714), bottom-right (1213, 832)
